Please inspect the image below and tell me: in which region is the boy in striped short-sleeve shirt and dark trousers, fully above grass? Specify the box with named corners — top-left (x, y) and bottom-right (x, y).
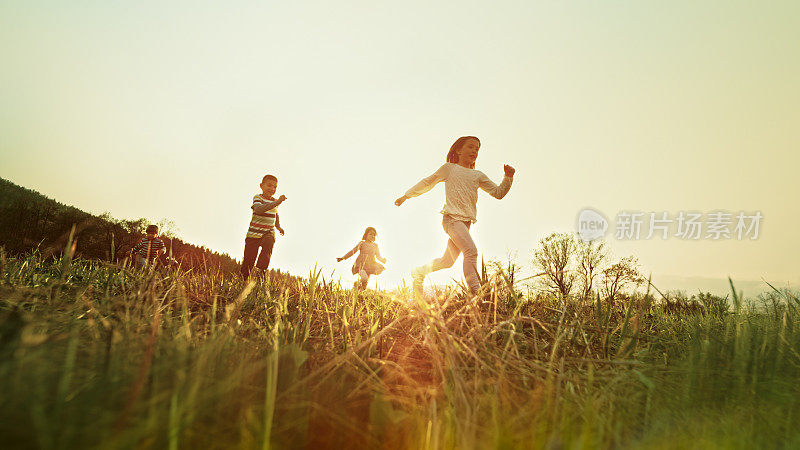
top-left (242, 175), bottom-right (286, 279)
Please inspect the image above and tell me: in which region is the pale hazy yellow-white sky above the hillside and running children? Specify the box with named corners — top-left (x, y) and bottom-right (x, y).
top-left (0, 1), bottom-right (800, 296)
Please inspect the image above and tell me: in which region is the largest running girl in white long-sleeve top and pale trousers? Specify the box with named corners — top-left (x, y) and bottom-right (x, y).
top-left (394, 136), bottom-right (514, 294)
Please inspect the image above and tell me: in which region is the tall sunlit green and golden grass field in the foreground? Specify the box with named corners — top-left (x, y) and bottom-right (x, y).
top-left (0, 244), bottom-right (800, 449)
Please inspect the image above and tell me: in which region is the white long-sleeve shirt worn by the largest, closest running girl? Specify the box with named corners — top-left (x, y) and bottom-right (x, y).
top-left (405, 162), bottom-right (513, 223)
